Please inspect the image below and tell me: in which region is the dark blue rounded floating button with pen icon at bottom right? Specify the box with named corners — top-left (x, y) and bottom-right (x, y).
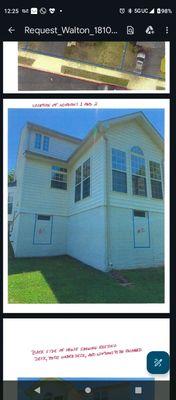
top-left (147, 351), bottom-right (170, 375)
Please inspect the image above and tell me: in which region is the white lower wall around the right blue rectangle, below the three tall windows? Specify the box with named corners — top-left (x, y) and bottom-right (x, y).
top-left (110, 207), bottom-right (164, 269)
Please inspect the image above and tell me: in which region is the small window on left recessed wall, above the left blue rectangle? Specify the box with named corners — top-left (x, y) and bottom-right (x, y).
top-left (51, 165), bottom-right (67, 190)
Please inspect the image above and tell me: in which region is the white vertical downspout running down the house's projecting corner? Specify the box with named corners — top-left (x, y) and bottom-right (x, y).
top-left (103, 135), bottom-right (113, 271)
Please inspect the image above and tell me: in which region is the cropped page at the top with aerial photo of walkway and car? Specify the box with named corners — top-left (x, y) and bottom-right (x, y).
top-left (4, 41), bottom-right (169, 93)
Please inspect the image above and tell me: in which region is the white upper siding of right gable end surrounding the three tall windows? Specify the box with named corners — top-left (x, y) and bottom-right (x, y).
top-left (107, 121), bottom-right (164, 212)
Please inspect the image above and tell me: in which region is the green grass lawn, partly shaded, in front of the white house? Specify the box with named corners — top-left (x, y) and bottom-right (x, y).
top-left (9, 244), bottom-right (164, 304)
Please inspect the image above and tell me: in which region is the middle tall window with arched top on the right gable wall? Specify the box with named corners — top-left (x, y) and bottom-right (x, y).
top-left (131, 147), bottom-right (147, 196)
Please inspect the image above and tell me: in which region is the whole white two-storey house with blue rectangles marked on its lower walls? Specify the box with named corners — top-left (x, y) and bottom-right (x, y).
top-left (11, 112), bottom-right (164, 271)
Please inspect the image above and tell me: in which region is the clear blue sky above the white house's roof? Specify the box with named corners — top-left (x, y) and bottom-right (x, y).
top-left (8, 108), bottom-right (164, 170)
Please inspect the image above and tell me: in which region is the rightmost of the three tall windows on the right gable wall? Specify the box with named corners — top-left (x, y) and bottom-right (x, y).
top-left (149, 161), bottom-right (163, 199)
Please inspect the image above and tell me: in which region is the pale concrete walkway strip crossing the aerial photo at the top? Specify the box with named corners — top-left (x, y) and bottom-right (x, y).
top-left (18, 50), bottom-right (165, 91)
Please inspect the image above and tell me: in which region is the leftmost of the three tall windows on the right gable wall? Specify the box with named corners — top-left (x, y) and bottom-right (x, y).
top-left (112, 149), bottom-right (127, 193)
